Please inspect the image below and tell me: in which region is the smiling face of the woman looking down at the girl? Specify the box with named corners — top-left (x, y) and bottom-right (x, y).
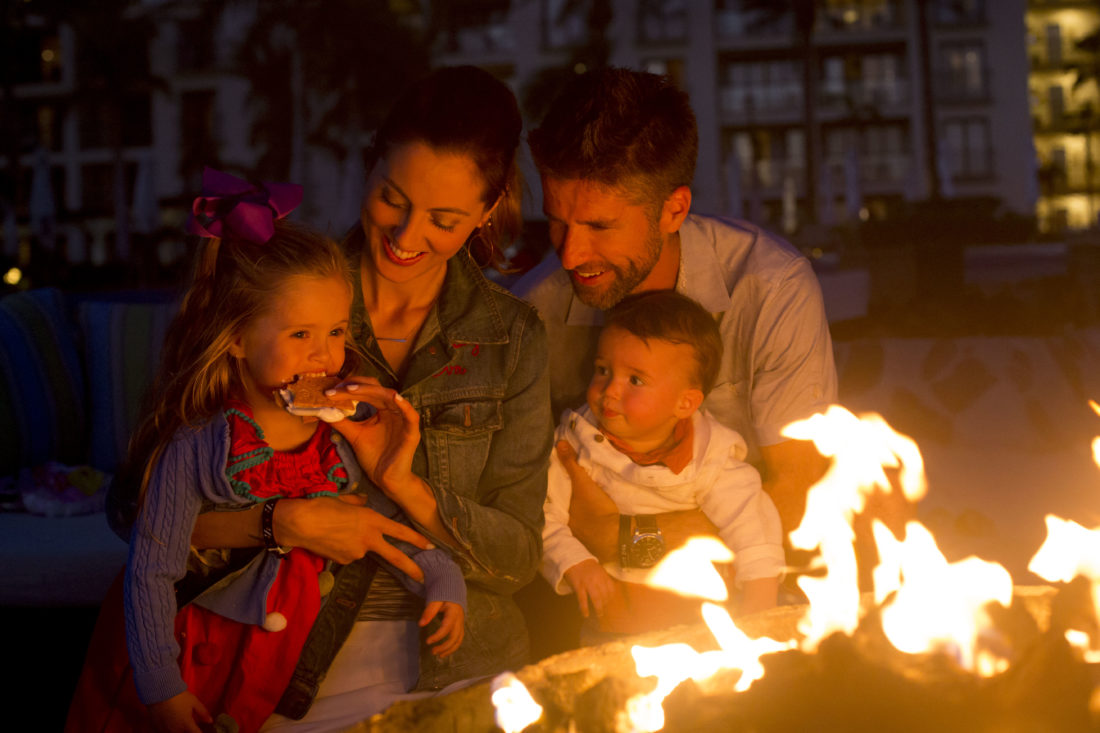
top-left (360, 142), bottom-right (492, 282)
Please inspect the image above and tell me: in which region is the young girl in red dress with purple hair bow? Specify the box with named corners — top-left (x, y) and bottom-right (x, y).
top-left (124, 171), bottom-right (465, 732)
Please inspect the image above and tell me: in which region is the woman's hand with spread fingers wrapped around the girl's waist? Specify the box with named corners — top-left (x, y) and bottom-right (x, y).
top-left (274, 494), bottom-right (431, 582)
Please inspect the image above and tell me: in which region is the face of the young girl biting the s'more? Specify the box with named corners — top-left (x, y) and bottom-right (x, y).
top-left (229, 275), bottom-right (351, 408)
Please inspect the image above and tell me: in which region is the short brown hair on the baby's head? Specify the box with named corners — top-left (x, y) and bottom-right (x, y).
top-left (604, 291), bottom-right (722, 395)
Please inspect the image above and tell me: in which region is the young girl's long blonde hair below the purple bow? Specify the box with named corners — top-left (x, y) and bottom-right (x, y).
top-left (116, 219), bottom-right (353, 512)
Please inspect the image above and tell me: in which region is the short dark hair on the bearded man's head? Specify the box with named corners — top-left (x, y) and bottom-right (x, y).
top-left (527, 68), bottom-right (699, 203)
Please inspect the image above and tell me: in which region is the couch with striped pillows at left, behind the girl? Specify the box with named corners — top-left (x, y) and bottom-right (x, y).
top-left (0, 288), bottom-right (176, 608)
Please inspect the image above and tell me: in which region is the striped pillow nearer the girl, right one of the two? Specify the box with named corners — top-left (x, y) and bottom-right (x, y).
top-left (77, 300), bottom-right (176, 471)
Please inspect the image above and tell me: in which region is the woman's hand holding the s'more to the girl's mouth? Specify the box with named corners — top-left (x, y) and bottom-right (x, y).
top-left (328, 376), bottom-right (420, 503)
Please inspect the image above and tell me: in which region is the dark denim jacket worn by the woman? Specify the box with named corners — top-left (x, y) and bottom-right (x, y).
top-left (278, 250), bottom-right (553, 718)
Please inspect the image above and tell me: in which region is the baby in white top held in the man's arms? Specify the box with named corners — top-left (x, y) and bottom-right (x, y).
top-left (541, 291), bottom-right (783, 641)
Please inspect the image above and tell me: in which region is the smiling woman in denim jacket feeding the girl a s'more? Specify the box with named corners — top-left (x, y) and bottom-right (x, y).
top-left (78, 67), bottom-right (552, 731)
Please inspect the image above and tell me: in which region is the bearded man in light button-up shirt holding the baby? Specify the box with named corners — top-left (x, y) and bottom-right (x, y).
top-left (514, 68), bottom-right (837, 651)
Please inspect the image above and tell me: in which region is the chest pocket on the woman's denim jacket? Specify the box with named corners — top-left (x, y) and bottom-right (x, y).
top-left (420, 400), bottom-right (504, 496)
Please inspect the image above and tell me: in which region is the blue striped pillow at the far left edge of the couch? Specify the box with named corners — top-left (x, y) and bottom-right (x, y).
top-left (0, 287), bottom-right (88, 475)
